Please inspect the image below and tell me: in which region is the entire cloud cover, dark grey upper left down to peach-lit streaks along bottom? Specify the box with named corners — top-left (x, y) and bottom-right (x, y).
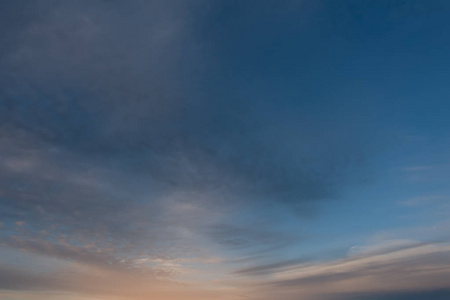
top-left (0, 0), bottom-right (450, 300)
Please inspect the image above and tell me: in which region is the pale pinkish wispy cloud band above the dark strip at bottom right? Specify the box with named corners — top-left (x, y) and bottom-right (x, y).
top-left (256, 243), bottom-right (450, 299)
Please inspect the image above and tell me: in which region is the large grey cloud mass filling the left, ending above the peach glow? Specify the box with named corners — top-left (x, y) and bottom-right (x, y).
top-left (0, 1), bottom-right (372, 274)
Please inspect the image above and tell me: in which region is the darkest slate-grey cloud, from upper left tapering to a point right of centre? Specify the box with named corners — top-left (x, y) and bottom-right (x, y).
top-left (0, 1), bottom-right (362, 202)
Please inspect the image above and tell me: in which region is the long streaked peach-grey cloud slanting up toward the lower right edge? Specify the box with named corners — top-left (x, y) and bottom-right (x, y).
top-left (241, 242), bottom-right (450, 299)
